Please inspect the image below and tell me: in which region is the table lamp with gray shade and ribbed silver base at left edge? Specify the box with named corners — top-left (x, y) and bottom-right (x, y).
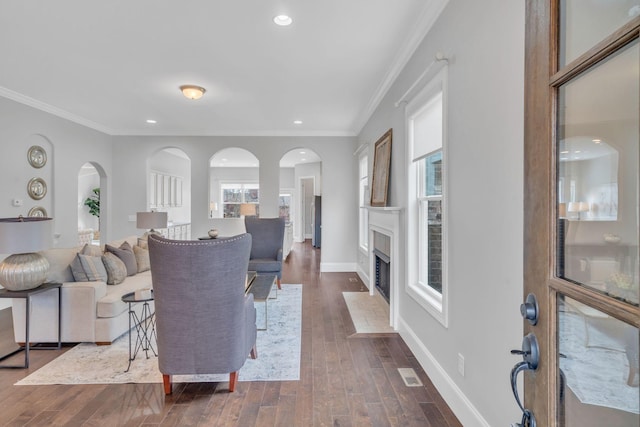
top-left (0, 216), bottom-right (52, 291)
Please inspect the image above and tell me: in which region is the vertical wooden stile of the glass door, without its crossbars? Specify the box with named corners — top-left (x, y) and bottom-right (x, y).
top-left (523, 0), bottom-right (557, 425)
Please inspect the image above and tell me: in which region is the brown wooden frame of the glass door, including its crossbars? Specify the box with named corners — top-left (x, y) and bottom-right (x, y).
top-left (523, 0), bottom-right (640, 425)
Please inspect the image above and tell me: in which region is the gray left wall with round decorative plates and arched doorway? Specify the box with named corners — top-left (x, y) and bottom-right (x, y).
top-left (0, 97), bottom-right (112, 246)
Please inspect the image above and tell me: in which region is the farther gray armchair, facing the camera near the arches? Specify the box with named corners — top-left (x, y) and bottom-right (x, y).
top-left (244, 217), bottom-right (284, 289)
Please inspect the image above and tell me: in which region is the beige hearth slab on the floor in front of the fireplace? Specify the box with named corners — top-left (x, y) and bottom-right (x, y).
top-left (342, 292), bottom-right (395, 334)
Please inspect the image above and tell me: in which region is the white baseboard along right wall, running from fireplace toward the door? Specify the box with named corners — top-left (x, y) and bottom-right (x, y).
top-left (398, 317), bottom-right (491, 427)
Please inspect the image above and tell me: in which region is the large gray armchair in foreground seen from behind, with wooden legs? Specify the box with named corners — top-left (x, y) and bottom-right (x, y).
top-left (149, 234), bottom-right (257, 394)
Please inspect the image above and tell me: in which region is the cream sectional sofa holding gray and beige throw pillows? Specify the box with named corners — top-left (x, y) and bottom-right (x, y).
top-left (13, 236), bottom-right (153, 344)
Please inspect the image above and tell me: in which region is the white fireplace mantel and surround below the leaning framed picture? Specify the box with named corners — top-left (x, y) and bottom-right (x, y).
top-left (368, 206), bottom-right (402, 330)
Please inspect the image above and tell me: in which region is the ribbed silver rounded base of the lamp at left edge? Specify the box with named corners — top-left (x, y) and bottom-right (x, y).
top-left (0, 252), bottom-right (49, 291)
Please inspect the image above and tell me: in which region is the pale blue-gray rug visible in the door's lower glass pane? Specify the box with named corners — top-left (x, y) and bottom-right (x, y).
top-left (559, 312), bottom-right (640, 414)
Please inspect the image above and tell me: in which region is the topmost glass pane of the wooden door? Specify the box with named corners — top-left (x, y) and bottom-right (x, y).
top-left (559, 0), bottom-right (640, 67)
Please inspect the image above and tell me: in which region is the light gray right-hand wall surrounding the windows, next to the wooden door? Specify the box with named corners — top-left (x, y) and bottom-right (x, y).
top-left (351, 0), bottom-right (524, 426)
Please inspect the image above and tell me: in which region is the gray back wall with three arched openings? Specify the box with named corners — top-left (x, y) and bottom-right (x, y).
top-left (112, 136), bottom-right (358, 271)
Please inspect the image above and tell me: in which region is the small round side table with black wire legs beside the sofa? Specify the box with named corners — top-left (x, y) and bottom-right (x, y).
top-left (122, 290), bottom-right (158, 372)
